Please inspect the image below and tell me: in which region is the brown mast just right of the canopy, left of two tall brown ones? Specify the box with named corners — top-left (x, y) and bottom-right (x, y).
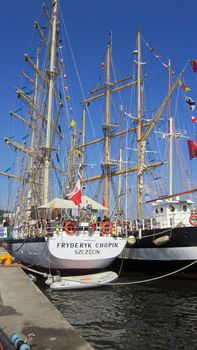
top-left (104, 38), bottom-right (111, 215)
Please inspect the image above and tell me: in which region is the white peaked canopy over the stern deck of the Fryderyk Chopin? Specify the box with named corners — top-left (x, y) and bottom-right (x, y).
top-left (38, 196), bottom-right (109, 210)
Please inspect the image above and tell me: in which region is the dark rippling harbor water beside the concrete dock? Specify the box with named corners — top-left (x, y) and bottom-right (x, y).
top-left (38, 272), bottom-right (197, 350)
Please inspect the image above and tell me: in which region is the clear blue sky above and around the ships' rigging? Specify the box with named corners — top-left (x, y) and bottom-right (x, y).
top-left (0, 0), bottom-right (197, 208)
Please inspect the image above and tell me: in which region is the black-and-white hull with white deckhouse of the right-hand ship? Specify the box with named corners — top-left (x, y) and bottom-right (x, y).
top-left (119, 200), bottom-right (197, 272)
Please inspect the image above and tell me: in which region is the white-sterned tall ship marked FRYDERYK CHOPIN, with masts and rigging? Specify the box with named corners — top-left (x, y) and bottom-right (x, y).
top-left (0, 0), bottom-right (127, 273)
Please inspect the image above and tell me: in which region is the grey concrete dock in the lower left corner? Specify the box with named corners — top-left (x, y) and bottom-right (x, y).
top-left (0, 266), bottom-right (94, 350)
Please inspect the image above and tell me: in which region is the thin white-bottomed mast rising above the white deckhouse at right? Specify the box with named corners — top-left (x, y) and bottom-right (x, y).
top-left (168, 60), bottom-right (173, 200)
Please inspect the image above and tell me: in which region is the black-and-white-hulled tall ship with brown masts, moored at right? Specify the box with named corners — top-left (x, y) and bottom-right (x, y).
top-left (76, 32), bottom-right (197, 272)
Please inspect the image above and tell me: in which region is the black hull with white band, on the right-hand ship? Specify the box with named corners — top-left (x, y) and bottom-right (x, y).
top-left (116, 226), bottom-right (197, 277)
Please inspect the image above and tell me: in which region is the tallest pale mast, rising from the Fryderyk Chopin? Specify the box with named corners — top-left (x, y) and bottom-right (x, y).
top-left (43, 0), bottom-right (57, 203)
